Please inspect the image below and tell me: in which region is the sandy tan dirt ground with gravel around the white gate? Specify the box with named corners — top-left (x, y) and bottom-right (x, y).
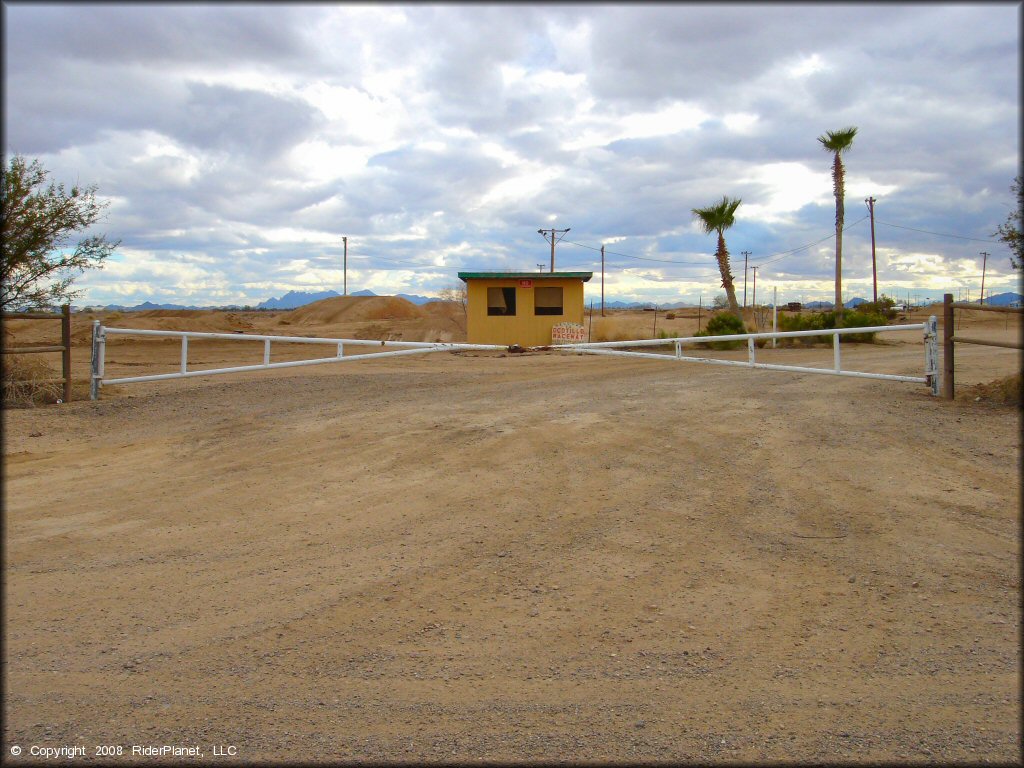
top-left (3, 307), bottom-right (1022, 764)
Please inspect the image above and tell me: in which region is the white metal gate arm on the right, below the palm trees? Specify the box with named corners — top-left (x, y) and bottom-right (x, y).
top-left (552, 315), bottom-right (939, 395)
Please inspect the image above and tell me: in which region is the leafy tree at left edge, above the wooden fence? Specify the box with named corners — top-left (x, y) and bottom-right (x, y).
top-left (0, 155), bottom-right (121, 310)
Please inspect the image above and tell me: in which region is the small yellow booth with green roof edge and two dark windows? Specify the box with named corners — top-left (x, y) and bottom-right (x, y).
top-left (459, 272), bottom-right (594, 347)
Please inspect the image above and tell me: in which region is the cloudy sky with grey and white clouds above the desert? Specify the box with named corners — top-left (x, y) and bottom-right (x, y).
top-left (3, 2), bottom-right (1021, 305)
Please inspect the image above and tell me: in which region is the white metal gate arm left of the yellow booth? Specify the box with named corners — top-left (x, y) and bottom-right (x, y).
top-left (89, 321), bottom-right (508, 400)
